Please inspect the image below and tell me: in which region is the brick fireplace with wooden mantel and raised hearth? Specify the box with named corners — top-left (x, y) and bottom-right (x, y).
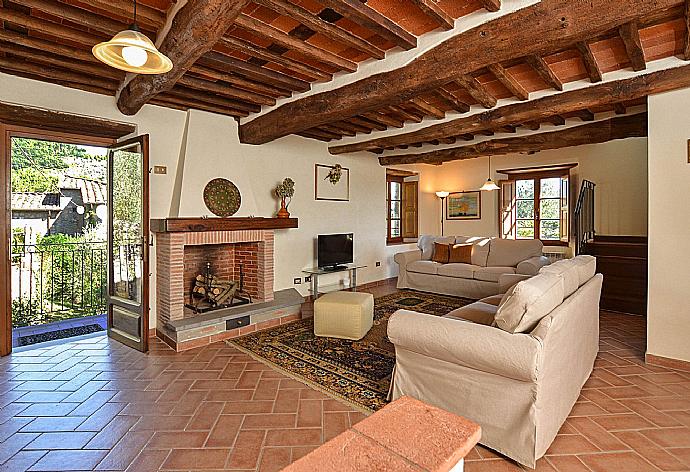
top-left (151, 218), bottom-right (303, 351)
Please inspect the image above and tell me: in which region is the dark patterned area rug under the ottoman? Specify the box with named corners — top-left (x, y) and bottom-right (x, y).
top-left (227, 290), bottom-right (472, 411)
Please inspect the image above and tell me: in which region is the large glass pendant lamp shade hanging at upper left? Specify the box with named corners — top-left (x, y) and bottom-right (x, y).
top-left (92, 29), bottom-right (173, 74)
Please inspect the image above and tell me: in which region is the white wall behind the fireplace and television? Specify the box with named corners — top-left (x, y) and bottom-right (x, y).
top-left (0, 74), bottom-right (404, 327)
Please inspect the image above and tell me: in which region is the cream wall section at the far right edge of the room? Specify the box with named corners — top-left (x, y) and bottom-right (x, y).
top-left (647, 89), bottom-right (690, 361)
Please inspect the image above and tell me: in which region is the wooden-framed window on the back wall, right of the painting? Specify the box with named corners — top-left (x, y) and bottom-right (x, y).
top-left (499, 166), bottom-right (572, 247)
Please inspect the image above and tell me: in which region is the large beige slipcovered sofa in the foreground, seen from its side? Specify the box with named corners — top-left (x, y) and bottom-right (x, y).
top-left (388, 256), bottom-right (602, 467)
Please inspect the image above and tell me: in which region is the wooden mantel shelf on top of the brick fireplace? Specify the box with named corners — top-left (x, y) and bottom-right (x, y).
top-left (151, 218), bottom-right (297, 233)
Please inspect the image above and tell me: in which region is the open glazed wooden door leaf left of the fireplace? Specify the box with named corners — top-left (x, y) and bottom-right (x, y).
top-left (108, 135), bottom-right (149, 352)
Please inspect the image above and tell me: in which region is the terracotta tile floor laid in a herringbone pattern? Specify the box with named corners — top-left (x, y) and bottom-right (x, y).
top-left (0, 288), bottom-right (690, 472)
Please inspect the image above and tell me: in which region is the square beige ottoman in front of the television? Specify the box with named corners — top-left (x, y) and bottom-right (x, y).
top-left (314, 292), bottom-right (374, 339)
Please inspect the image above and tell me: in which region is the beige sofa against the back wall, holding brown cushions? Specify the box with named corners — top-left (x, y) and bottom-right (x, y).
top-left (394, 236), bottom-right (549, 299)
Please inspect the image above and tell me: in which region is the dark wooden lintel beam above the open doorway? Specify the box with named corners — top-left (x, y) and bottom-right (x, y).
top-left (0, 98), bottom-right (137, 139)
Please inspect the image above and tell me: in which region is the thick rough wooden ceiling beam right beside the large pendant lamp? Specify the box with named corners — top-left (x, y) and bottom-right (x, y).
top-left (117, 0), bottom-right (248, 115)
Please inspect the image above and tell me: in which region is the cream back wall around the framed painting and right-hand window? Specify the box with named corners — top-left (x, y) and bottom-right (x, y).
top-left (390, 138), bottom-right (647, 240)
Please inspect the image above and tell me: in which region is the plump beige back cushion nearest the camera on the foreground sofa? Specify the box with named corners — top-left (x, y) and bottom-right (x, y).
top-left (494, 273), bottom-right (564, 333)
